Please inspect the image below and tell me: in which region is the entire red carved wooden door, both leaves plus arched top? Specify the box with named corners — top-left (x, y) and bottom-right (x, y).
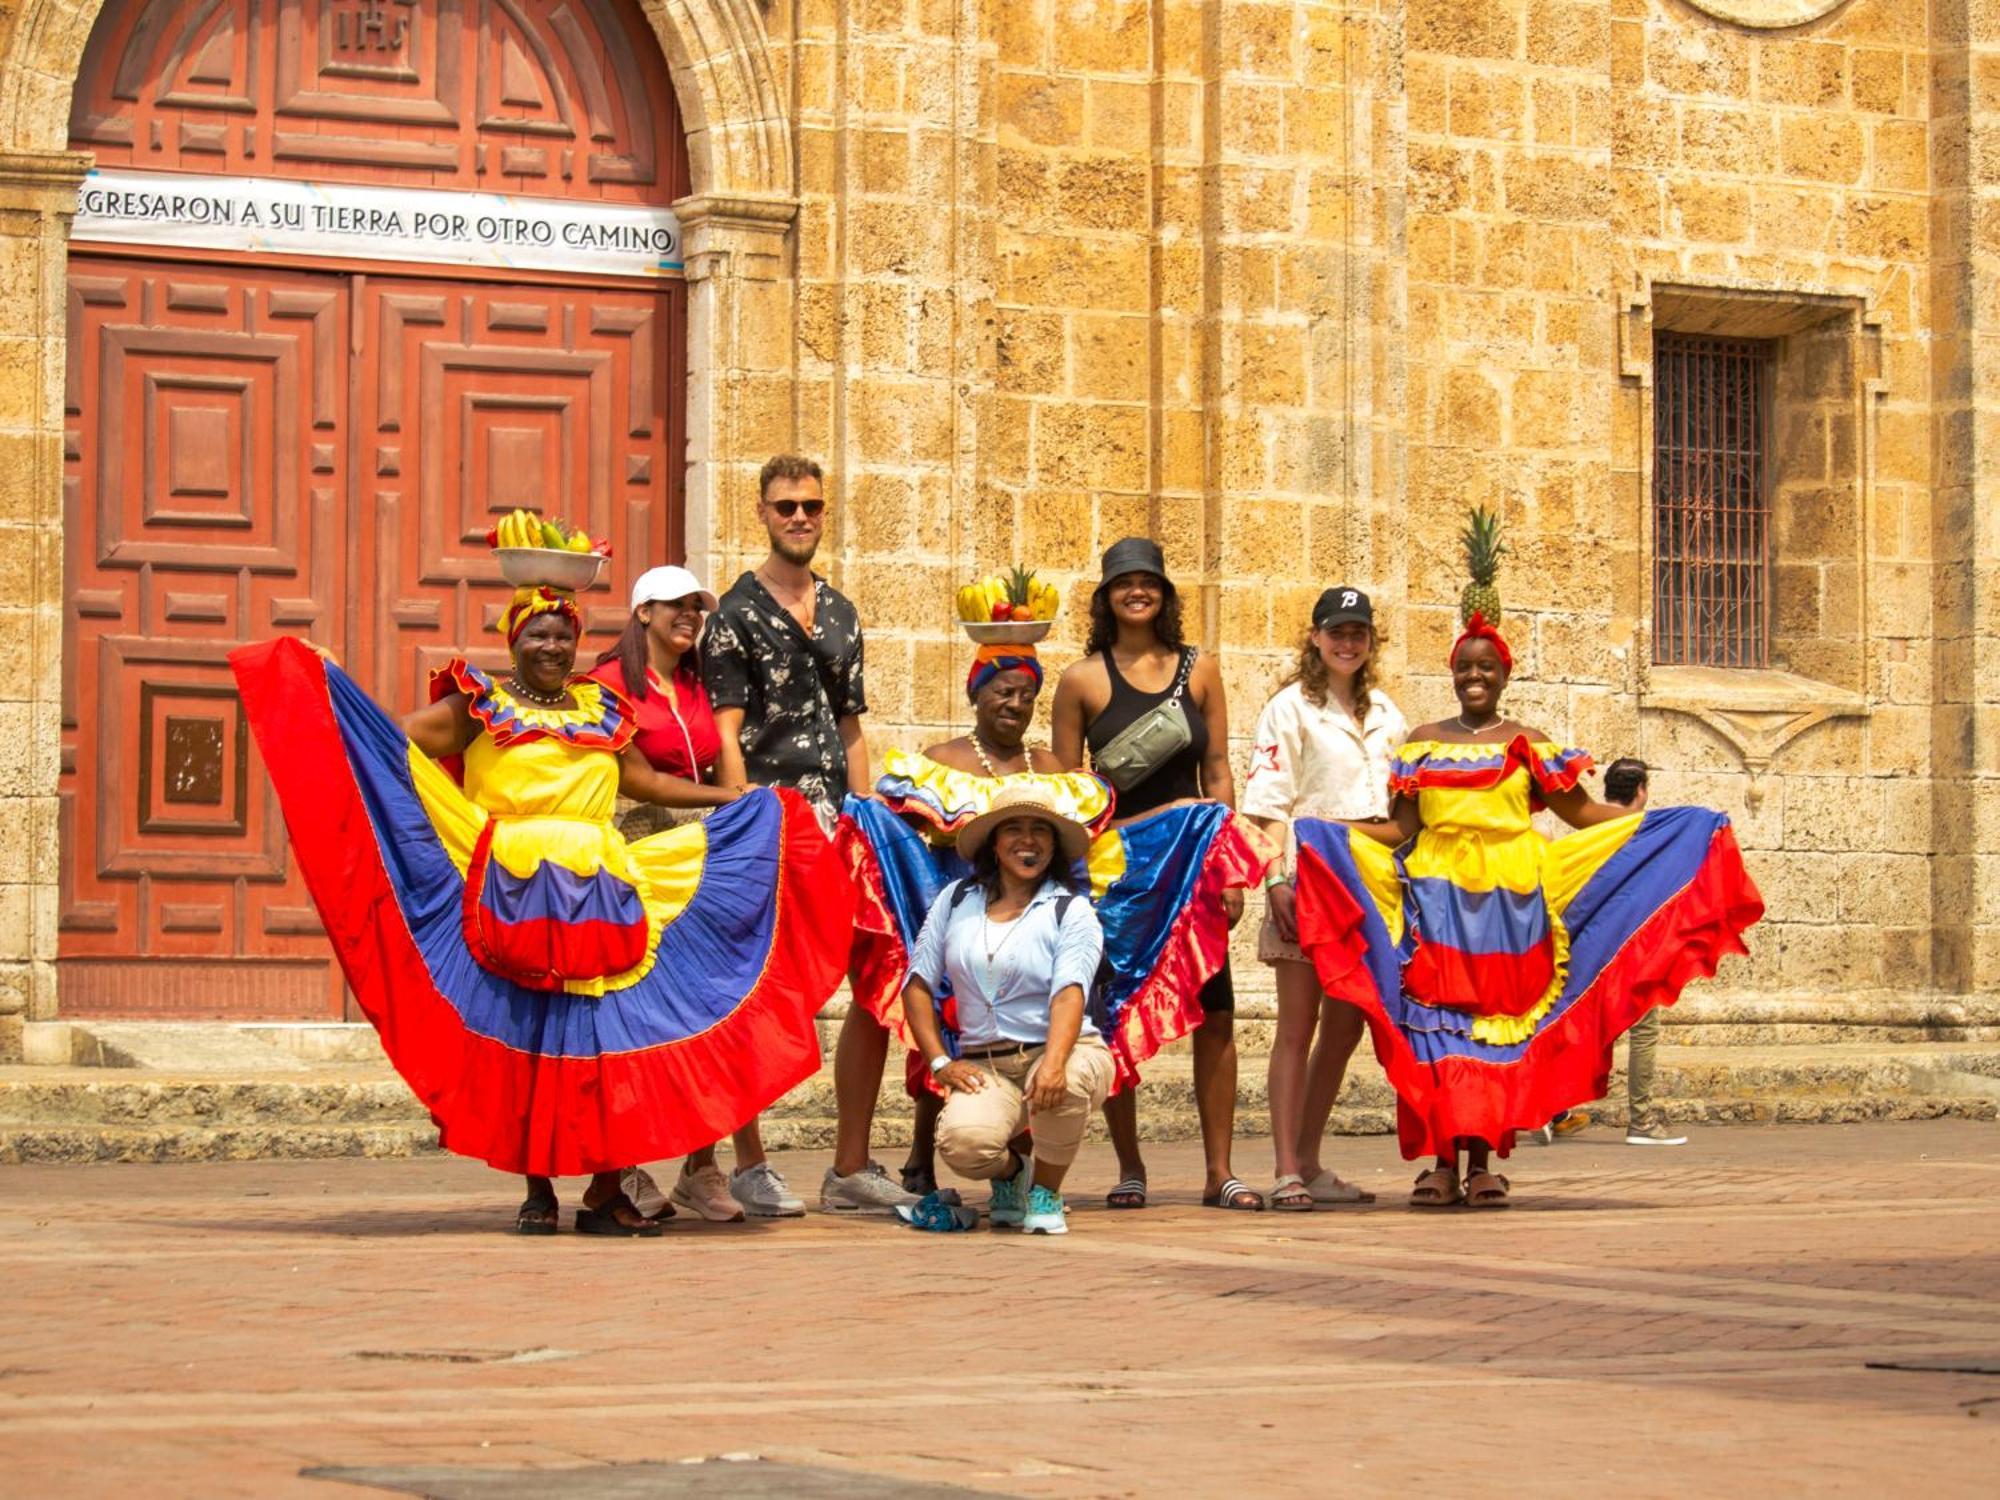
top-left (60, 0), bottom-right (688, 1016)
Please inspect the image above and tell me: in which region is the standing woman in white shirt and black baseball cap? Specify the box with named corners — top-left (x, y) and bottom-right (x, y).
top-left (1242, 588), bottom-right (1410, 1210)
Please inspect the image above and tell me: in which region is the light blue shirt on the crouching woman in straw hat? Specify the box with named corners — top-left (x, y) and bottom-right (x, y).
top-left (910, 882), bottom-right (1104, 1046)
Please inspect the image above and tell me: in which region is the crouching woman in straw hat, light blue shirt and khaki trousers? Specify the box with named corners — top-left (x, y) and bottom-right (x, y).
top-left (902, 786), bottom-right (1116, 1234)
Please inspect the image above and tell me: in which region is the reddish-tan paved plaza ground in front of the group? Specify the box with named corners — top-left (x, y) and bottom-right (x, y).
top-left (0, 1120), bottom-right (2000, 1500)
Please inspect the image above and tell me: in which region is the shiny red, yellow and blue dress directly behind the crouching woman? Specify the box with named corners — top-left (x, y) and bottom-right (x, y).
top-left (834, 750), bottom-right (1264, 1086)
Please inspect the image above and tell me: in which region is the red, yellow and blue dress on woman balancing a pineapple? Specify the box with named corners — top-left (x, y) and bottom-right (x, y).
top-left (1296, 736), bottom-right (1764, 1160)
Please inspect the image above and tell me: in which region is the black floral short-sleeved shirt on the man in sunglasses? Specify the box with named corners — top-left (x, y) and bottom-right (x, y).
top-left (702, 572), bottom-right (868, 822)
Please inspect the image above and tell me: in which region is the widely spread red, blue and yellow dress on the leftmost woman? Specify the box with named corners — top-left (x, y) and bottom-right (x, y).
top-left (230, 640), bottom-right (852, 1176)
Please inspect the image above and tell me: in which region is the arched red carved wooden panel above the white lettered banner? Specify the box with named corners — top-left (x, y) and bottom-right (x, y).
top-left (70, 0), bottom-right (688, 204)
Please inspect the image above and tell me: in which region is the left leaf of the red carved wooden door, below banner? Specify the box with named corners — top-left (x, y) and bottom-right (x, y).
top-left (60, 258), bottom-right (350, 1014)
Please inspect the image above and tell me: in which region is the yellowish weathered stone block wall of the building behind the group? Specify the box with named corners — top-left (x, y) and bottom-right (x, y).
top-left (0, 0), bottom-right (2000, 1042)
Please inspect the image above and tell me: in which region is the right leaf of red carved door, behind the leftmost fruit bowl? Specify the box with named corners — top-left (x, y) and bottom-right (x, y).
top-left (354, 278), bottom-right (684, 710)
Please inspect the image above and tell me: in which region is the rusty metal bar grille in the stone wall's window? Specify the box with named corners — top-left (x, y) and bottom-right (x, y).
top-left (1652, 332), bottom-right (1774, 666)
